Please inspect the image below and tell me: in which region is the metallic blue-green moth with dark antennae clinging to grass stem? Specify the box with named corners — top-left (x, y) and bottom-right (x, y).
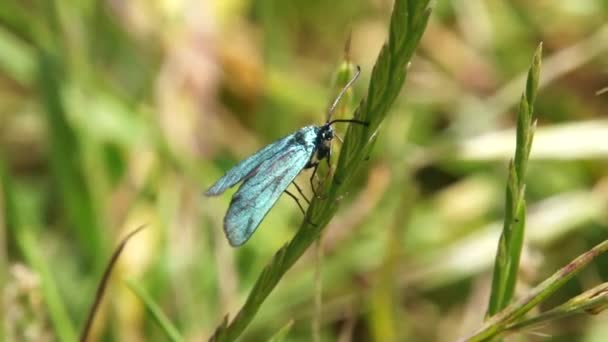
top-left (205, 66), bottom-right (368, 247)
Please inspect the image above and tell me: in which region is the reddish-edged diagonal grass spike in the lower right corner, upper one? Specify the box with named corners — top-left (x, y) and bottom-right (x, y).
top-left (464, 240), bottom-right (608, 342)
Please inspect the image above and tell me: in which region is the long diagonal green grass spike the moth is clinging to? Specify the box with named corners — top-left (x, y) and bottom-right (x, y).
top-left (211, 0), bottom-right (430, 341)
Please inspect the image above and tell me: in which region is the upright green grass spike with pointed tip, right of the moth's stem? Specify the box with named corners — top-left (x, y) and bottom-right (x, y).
top-left (487, 44), bottom-right (542, 317)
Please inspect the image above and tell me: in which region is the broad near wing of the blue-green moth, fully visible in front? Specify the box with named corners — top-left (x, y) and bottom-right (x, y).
top-left (224, 144), bottom-right (314, 246)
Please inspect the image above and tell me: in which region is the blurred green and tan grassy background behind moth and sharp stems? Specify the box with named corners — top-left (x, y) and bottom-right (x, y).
top-left (0, 0), bottom-right (608, 341)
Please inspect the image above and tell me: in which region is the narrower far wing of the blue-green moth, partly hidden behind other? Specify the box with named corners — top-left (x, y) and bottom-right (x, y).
top-left (205, 134), bottom-right (293, 196)
